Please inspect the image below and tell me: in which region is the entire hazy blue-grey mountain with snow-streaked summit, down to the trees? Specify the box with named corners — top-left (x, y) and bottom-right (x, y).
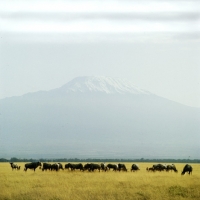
top-left (0, 77), bottom-right (200, 159)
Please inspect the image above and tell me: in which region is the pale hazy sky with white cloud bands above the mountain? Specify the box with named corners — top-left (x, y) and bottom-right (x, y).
top-left (0, 0), bottom-right (200, 107)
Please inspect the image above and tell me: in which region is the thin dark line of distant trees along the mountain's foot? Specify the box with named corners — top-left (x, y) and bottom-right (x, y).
top-left (0, 157), bottom-right (200, 163)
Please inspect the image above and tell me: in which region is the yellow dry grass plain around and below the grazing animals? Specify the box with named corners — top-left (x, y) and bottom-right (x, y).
top-left (0, 163), bottom-right (200, 200)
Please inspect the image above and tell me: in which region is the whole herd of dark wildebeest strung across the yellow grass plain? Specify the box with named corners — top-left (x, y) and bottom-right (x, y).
top-left (10, 162), bottom-right (193, 175)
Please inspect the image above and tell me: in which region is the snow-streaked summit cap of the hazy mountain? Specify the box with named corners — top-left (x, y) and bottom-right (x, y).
top-left (61, 76), bottom-right (150, 94)
